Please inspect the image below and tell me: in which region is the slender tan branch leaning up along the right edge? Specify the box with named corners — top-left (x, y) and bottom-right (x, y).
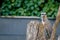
top-left (50, 6), bottom-right (60, 40)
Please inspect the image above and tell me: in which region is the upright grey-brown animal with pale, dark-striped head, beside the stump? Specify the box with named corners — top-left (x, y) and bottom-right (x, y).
top-left (42, 13), bottom-right (52, 40)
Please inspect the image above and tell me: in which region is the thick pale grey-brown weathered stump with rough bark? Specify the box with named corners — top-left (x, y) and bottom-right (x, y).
top-left (26, 20), bottom-right (39, 40)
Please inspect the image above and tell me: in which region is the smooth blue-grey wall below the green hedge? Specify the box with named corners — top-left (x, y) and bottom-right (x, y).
top-left (0, 18), bottom-right (60, 40)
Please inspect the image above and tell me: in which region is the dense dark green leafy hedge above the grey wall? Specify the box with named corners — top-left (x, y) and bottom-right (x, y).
top-left (0, 0), bottom-right (59, 18)
